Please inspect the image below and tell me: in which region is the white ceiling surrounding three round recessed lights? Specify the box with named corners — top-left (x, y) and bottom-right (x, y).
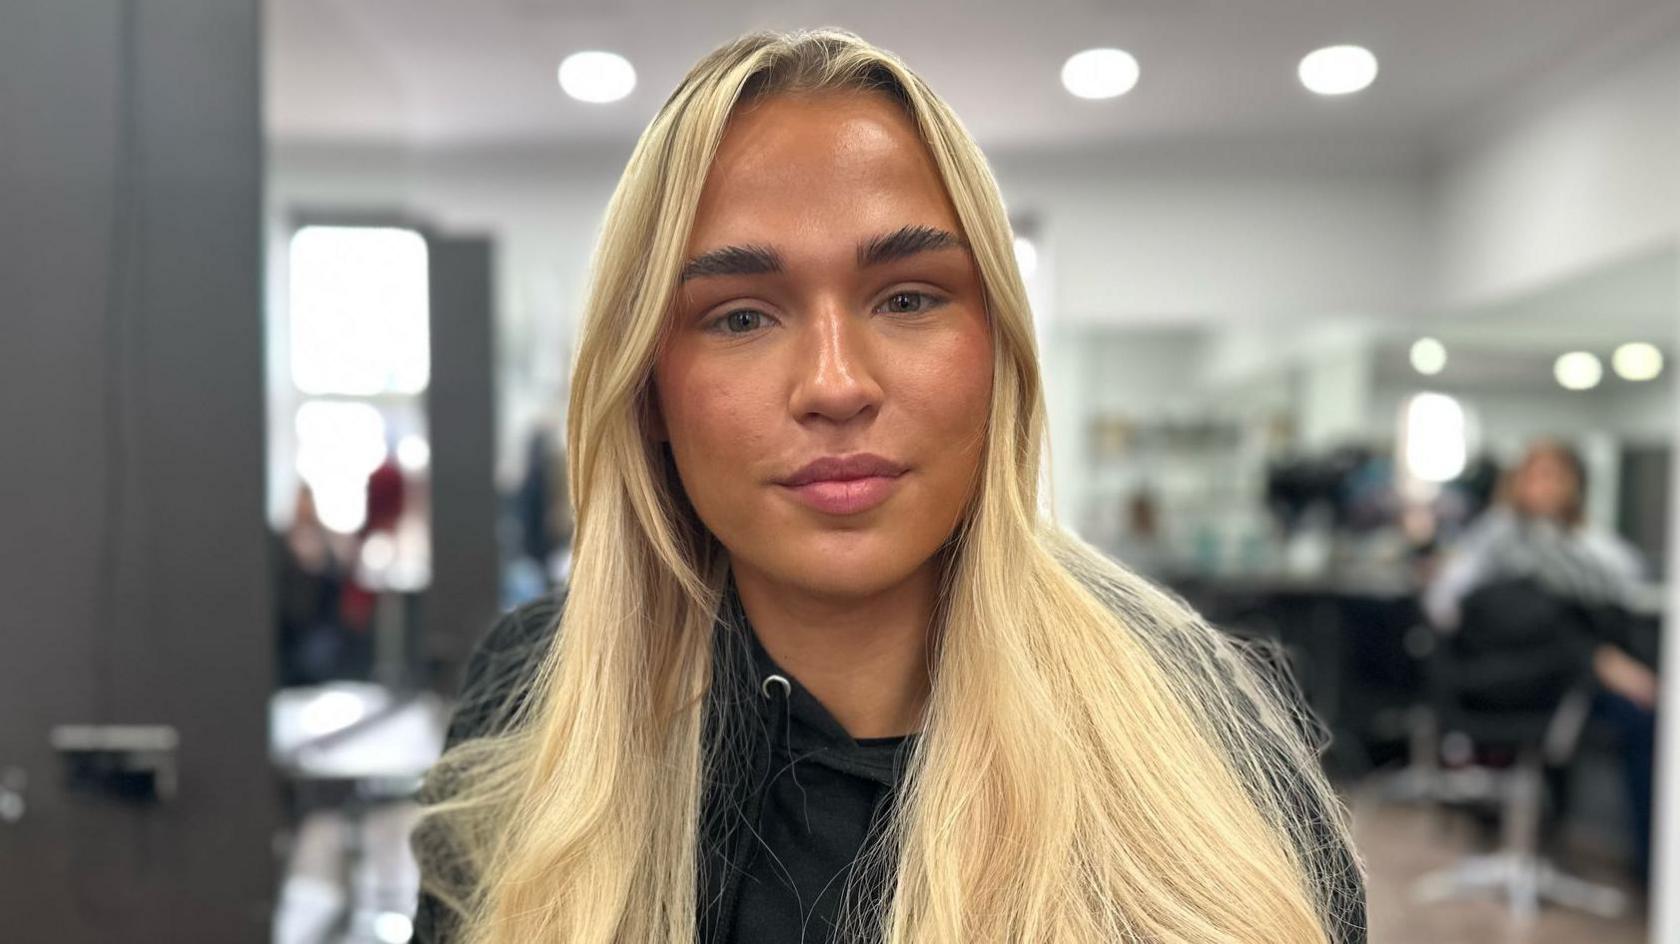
top-left (265, 0), bottom-right (1680, 160)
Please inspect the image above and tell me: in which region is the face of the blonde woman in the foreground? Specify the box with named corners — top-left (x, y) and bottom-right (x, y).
top-left (654, 92), bottom-right (993, 596)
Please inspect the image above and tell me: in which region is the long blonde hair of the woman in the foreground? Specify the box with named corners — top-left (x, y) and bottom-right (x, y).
top-left (427, 30), bottom-right (1359, 944)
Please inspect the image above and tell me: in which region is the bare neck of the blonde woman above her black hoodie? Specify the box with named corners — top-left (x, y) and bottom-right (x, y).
top-left (732, 559), bottom-right (939, 737)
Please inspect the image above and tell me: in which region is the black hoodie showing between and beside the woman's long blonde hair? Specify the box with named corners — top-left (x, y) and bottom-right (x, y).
top-left (413, 581), bottom-right (1364, 944)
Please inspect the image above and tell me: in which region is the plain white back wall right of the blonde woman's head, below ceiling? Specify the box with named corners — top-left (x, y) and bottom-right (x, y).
top-left (996, 156), bottom-right (1428, 324)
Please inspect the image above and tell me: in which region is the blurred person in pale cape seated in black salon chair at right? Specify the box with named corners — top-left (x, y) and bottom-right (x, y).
top-left (1423, 440), bottom-right (1658, 882)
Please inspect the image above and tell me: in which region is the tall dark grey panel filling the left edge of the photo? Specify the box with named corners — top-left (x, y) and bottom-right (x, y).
top-left (0, 0), bottom-right (276, 942)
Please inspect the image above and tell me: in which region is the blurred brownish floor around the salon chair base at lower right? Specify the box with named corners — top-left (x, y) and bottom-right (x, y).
top-left (1352, 786), bottom-right (1648, 944)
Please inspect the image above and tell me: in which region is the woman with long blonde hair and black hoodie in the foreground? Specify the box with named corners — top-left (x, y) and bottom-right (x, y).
top-left (415, 30), bottom-right (1364, 944)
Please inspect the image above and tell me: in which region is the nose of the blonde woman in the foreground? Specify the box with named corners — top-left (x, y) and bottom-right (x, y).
top-left (791, 302), bottom-right (882, 422)
